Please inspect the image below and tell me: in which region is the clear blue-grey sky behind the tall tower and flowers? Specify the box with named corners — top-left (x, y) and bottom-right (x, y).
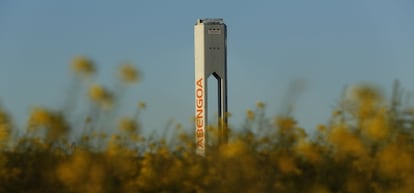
top-left (0, 0), bottom-right (414, 134)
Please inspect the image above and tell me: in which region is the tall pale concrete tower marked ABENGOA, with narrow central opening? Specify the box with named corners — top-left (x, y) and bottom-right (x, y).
top-left (194, 19), bottom-right (228, 156)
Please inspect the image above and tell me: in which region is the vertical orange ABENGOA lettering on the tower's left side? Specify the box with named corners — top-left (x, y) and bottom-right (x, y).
top-left (195, 78), bottom-right (205, 151)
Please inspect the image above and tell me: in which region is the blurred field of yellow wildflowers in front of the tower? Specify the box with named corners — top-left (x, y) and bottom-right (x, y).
top-left (0, 57), bottom-right (414, 193)
